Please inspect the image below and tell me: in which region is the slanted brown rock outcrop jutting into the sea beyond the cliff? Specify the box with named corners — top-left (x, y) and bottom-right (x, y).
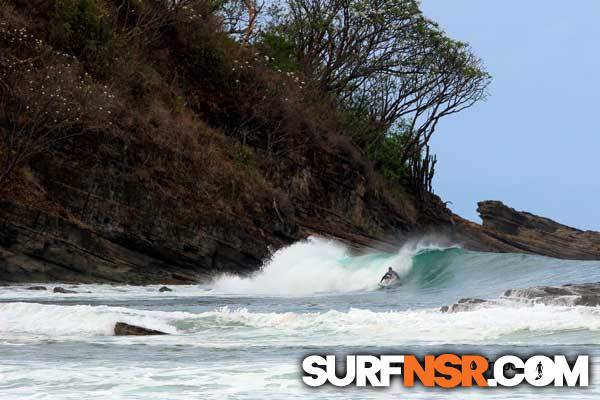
top-left (452, 201), bottom-right (600, 260)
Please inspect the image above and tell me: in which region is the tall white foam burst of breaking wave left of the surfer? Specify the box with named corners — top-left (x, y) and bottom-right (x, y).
top-left (212, 237), bottom-right (454, 296)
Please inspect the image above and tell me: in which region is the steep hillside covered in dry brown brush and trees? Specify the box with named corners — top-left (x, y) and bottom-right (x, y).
top-left (0, 0), bottom-right (490, 279)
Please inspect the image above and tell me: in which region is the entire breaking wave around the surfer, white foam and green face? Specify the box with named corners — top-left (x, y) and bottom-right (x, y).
top-left (209, 237), bottom-right (600, 300)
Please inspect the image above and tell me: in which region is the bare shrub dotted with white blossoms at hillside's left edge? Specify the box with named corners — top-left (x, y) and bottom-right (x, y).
top-left (0, 19), bottom-right (115, 185)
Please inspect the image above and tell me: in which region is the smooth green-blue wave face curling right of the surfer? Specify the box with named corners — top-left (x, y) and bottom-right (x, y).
top-left (368, 248), bottom-right (600, 306)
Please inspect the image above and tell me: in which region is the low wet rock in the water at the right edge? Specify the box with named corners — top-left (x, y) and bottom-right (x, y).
top-left (504, 283), bottom-right (600, 307)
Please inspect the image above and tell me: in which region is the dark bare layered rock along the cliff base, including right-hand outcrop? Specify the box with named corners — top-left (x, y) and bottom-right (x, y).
top-left (0, 185), bottom-right (600, 284)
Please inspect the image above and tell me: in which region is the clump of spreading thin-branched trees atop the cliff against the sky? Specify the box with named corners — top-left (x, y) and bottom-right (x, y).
top-left (271, 0), bottom-right (491, 188)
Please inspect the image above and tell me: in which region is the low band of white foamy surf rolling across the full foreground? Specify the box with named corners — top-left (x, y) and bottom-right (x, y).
top-left (0, 303), bottom-right (600, 347)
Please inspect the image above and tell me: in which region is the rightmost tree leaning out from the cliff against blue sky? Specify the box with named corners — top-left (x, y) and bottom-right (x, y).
top-left (350, 37), bottom-right (490, 162)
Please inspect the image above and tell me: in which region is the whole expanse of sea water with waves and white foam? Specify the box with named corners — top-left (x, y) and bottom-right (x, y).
top-left (0, 238), bottom-right (600, 399)
